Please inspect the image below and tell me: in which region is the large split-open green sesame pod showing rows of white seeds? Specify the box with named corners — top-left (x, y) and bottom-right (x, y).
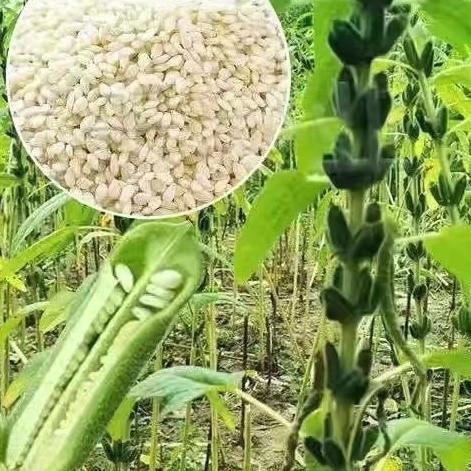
top-left (6, 222), bottom-right (202, 471)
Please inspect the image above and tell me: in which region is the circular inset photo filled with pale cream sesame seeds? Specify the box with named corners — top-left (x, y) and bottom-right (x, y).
top-left (7, 0), bottom-right (291, 217)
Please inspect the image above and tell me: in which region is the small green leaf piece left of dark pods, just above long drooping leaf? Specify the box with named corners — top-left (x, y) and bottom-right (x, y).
top-left (292, 118), bottom-right (342, 175)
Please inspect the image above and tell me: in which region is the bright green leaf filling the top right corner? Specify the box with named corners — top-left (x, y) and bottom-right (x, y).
top-left (421, 0), bottom-right (471, 51)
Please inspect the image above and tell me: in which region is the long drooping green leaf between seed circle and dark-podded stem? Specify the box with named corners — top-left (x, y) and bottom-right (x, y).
top-left (234, 170), bottom-right (327, 283)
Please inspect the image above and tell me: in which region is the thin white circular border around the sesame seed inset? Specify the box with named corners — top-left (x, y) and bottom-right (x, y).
top-left (5, 0), bottom-right (293, 221)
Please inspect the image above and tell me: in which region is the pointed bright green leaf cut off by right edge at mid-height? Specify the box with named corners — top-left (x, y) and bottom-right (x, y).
top-left (424, 224), bottom-right (471, 287)
